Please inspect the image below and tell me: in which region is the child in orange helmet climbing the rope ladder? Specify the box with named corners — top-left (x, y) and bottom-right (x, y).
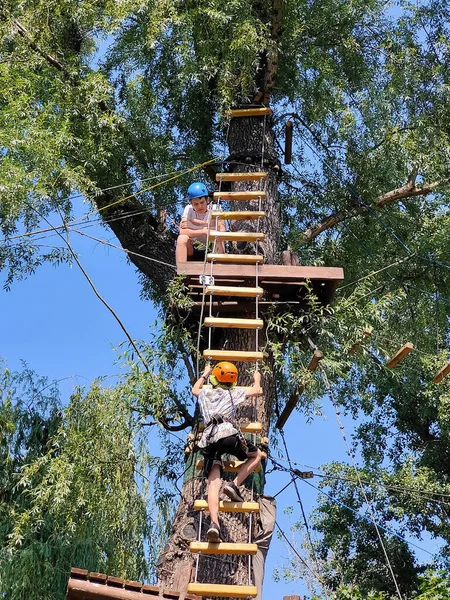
top-left (192, 362), bottom-right (262, 542)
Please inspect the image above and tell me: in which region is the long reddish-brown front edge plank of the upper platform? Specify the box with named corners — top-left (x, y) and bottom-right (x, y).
top-left (177, 262), bottom-right (344, 283)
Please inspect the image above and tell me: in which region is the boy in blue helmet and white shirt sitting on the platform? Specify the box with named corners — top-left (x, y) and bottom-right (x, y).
top-left (176, 181), bottom-right (225, 263)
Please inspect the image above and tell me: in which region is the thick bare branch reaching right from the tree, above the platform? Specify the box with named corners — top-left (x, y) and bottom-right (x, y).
top-left (301, 170), bottom-right (450, 244)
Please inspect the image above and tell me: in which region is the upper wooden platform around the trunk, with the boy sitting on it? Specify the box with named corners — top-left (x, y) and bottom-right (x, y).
top-left (177, 262), bottom-right (344, 315)
